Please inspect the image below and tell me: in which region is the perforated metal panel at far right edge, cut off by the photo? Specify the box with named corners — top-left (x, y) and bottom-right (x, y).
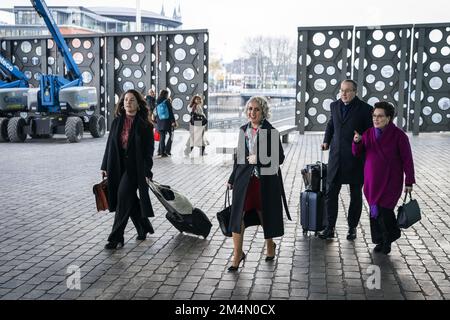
top-left (410, 23), bottom-right (450, 134)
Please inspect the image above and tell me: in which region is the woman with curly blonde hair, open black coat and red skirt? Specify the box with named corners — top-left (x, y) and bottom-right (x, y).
top-left (228, 97), bottom-right (290, 271)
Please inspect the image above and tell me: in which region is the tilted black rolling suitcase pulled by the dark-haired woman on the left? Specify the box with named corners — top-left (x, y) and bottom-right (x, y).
top-left (149, 181), bottom-right (212, 238)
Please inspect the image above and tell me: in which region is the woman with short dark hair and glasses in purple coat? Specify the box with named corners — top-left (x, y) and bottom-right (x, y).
top-left (352, 101), bottom-right (416, 254)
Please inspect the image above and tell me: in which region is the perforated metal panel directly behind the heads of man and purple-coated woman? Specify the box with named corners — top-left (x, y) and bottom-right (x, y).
top-left (353, 25), bottom-right (412, 130)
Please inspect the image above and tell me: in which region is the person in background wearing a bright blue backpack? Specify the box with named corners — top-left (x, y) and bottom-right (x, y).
top-left (153, 89), bottom-right (176, 157)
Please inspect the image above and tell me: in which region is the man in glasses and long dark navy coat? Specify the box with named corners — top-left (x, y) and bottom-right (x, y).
top-left (319, 80), bottom-right (372, 240)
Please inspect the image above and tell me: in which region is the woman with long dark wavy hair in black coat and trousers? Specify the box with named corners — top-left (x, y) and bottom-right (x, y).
top-left (101, 90), bottom-right (155, 249)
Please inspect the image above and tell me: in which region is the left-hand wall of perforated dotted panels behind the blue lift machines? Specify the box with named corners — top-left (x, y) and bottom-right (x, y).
top-left (1, 30), bottom-right (208, 128)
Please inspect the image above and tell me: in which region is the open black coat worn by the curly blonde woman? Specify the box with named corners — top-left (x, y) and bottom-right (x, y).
top-left (228, 120), bottom-right (289, 239)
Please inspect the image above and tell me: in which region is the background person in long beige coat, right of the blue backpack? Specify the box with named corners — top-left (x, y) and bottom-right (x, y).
top-left (185, 94), bottom-right (208, 156)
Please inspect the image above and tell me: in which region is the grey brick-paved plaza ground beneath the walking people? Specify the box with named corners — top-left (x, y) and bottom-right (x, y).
top-left (0, 131), bottom-right (450, 299)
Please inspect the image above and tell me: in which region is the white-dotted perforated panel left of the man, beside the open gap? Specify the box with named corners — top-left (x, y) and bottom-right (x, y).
top-left (295, 26), bottom-right (353, 133)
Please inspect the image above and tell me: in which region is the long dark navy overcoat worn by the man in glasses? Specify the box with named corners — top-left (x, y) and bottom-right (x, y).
top-left (323, 97), bottom-right (373, 184)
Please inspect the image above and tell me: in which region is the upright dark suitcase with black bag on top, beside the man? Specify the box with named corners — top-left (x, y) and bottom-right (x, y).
top-left (300, 152), bottom-right (327, 235)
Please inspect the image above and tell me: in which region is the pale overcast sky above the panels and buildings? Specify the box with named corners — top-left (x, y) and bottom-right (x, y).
top-left (0, 0), bottom-right (450, 61)
